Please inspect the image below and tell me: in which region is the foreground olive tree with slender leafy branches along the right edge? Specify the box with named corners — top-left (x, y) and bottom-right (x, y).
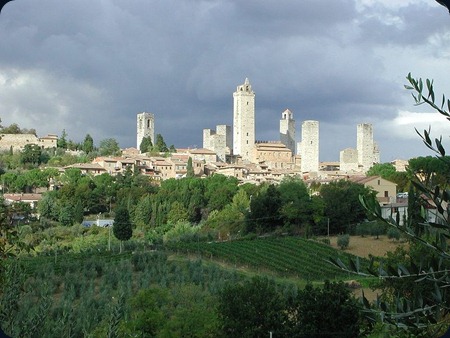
top-left (330, 74), bottom-right (450, 337)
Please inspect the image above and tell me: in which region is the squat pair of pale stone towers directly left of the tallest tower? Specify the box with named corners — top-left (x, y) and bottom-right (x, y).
top-left (203, 125), bottom-right (233, 162)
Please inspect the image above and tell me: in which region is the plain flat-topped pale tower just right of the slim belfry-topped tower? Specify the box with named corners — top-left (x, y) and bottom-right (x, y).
top-left (300, 121), bottom-right (319, 172)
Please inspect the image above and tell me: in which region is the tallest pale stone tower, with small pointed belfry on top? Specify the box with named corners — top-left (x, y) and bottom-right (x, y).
top-left (233, 78), bottom-right (255, 161)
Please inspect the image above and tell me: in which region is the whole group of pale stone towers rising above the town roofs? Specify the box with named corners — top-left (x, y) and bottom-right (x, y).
top-left (137, 78), bottom-right (380, 173)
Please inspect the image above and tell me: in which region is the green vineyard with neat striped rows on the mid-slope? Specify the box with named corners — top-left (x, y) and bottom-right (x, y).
top-left (166, 237), bottom-right (366, 281)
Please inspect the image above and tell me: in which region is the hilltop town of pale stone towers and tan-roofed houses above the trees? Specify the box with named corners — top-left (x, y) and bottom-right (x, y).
top-left (0, 79), bottom-right (407, 184)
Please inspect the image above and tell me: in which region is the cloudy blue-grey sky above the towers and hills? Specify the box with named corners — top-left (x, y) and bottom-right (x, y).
top-left (0, 0), bottom-right (450, 163)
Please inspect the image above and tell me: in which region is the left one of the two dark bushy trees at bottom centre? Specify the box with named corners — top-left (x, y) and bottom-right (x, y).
top-left (218, 277), bottom-right (285, 337)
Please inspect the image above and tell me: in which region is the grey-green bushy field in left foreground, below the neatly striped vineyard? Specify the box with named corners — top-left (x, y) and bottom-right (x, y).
top-left (0, 252), bottom-right (260, 338)
